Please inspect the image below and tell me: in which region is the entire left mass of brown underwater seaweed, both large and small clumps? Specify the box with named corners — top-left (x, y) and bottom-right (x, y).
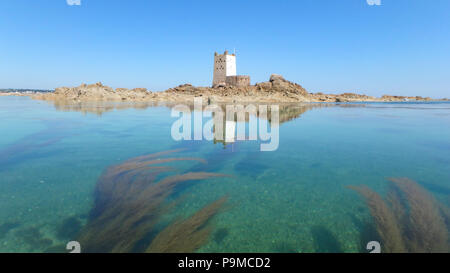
top-left (78, 150), bottom-right (227, 253)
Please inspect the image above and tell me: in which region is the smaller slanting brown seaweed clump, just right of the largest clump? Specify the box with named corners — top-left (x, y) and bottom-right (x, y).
top-left (146, 197), bottom-right (228, 253)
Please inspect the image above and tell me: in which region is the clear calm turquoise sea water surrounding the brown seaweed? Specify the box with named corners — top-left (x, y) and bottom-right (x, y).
top-left (0, 97), bottom-right (450, 253)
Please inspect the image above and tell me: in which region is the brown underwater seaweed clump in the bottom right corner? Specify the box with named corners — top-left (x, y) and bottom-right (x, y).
top-left (349, 178), bottom-right (450, 253)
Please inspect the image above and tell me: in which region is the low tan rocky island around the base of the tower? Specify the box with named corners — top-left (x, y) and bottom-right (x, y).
top-left (15, 74), bottom-right (447, 103)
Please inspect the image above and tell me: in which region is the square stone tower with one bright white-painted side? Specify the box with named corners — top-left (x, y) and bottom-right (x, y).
top-left (213, 51), bottom-right (236, 86)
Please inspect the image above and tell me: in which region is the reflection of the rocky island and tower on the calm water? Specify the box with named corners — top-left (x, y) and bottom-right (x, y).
top-left (46, 101), bottom-right (342, 150)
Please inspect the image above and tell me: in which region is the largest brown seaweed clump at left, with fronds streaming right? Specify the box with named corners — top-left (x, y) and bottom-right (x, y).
top-left (78, 150), bottom-right (229, 252)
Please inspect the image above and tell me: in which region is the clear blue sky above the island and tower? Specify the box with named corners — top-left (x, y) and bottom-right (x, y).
top-left (0, 0), bottom-right (450, 97)
